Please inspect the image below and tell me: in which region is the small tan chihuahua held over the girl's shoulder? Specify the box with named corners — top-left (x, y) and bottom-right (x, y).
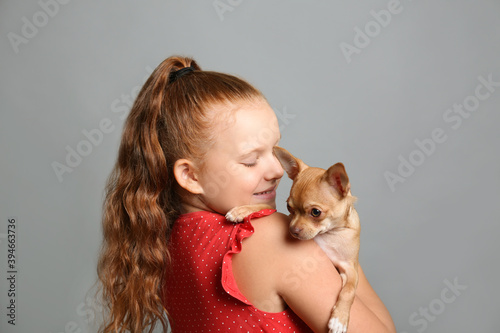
top-left (226, 147), bottom-right (361, 333)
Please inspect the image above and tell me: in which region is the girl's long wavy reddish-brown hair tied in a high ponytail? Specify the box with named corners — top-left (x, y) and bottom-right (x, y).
top-left (97, 56), bottom-right (264, 333)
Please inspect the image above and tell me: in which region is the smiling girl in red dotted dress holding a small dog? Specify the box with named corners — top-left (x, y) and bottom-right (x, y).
top-left (98, 57), bottom-right (395, 333)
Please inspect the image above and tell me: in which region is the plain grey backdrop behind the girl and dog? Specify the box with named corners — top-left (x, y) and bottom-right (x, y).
top-left (0, 0), bottom-right (500, 333)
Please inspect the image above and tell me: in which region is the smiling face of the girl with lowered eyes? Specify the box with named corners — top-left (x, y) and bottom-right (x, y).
top-left (194, 101), bottom-right (283, 214)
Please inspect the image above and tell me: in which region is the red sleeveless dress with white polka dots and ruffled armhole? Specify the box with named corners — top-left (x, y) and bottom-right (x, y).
top-left (164, 209), bottom-right (312, 333)
